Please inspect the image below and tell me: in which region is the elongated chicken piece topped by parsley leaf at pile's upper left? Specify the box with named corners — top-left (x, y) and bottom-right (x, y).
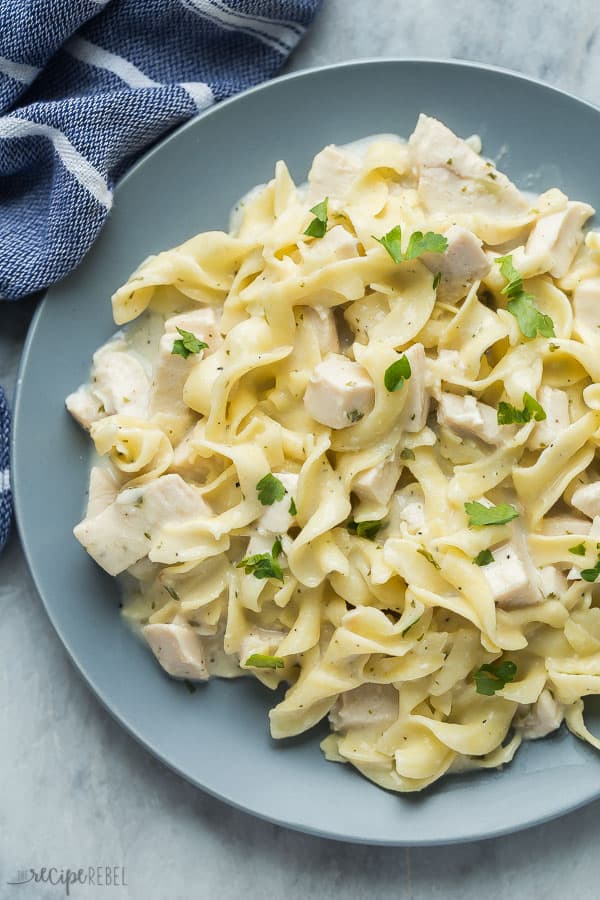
top-left (152, 306), bottom-right (223, 413)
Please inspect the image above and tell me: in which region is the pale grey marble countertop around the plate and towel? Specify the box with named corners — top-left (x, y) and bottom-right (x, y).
top-left (0, 0), bottom-right (600, 900)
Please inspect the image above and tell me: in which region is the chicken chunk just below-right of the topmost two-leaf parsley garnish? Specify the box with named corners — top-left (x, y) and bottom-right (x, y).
top-left (421, 225), bottom-right (491, 303)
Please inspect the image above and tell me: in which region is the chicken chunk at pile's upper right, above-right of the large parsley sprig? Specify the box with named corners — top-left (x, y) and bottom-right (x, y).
top-left (525, 200), bottom-right (594, 278)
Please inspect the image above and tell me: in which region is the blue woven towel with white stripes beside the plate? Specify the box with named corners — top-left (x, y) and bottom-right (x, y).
top-left (0, 0), bottom-right (320, 549)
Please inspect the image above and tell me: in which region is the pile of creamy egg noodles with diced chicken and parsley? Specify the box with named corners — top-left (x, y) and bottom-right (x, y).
top-left (67, 116), bottom-right (600, 791)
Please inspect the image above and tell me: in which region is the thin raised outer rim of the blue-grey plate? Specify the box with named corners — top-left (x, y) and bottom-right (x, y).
top-left (10, 56), bottom-right (600, 847)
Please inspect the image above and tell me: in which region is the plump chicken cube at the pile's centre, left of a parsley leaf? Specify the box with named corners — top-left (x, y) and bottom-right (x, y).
top-left (304, 353), bottom-right (376, 430)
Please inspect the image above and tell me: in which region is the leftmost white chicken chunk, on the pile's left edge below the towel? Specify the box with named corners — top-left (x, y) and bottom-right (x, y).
top-left (65, 340), bottom-right (150, 431)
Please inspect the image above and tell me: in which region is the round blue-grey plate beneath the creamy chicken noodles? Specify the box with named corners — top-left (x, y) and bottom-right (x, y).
top-left (13, 60), bottom-right (600, 845)
